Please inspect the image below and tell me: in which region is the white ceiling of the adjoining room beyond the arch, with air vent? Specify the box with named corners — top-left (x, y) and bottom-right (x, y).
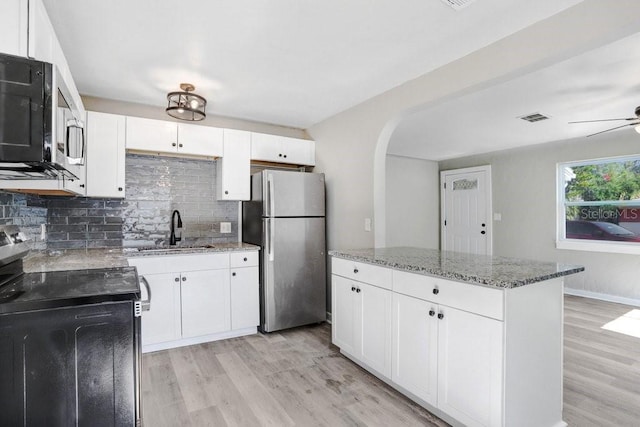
top-left (387, 29), bottom-right (640, 160)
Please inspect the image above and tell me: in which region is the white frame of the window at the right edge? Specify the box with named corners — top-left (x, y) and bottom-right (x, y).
top-left (556, 154), bottom-right (640, 255)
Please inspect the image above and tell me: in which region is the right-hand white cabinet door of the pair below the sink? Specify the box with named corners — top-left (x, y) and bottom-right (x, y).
top-left (180, 269), bottom-right (231, 338)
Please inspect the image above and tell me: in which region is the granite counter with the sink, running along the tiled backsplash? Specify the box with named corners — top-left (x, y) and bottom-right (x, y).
top-left (23, 243), bottom-right (259, 273)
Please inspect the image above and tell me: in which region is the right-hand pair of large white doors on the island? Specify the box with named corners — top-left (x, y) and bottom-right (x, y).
top-left (391, 294), bottom-right (503, 426)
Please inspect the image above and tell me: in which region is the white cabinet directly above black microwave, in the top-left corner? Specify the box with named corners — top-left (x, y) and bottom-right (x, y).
top-left (0, 0), bottom-right (29, 56)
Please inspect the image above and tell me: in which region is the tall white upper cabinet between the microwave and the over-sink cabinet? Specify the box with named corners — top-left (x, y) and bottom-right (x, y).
top-left (86, 111), bottom-right (125, 198)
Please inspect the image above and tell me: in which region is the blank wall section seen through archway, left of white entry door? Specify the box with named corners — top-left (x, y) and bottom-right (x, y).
top-left (386, 155), bottom-right (440, 249)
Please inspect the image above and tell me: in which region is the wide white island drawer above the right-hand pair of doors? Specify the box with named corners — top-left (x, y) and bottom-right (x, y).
top-left (393, 271), bottom-right (504, 320)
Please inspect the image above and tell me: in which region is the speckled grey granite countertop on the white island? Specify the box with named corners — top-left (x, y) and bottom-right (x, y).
top-left (329, 248), bottom-right (584, 288)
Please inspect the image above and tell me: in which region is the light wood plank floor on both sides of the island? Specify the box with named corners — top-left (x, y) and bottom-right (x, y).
top-left (142, 296), bottom-right (640, 427)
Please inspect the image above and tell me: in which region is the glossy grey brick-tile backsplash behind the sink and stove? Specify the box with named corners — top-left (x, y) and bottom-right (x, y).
top-left (0, 154), bottom-right (240, 249)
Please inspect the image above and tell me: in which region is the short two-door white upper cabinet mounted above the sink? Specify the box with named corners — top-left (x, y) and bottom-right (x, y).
top-left (127, 117), bottom-right (223, 157)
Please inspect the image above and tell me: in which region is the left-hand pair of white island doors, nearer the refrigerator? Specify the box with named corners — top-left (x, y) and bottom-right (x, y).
top-left (332, 275), bottom-right (392, 377)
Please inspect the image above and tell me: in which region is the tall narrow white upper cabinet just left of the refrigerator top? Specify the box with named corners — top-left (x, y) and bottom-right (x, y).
top-left (216, 129), bottom-right (251, 200)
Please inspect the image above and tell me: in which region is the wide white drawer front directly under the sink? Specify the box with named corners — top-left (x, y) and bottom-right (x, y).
top-left (127, 254), bottom-right (229, 274)
